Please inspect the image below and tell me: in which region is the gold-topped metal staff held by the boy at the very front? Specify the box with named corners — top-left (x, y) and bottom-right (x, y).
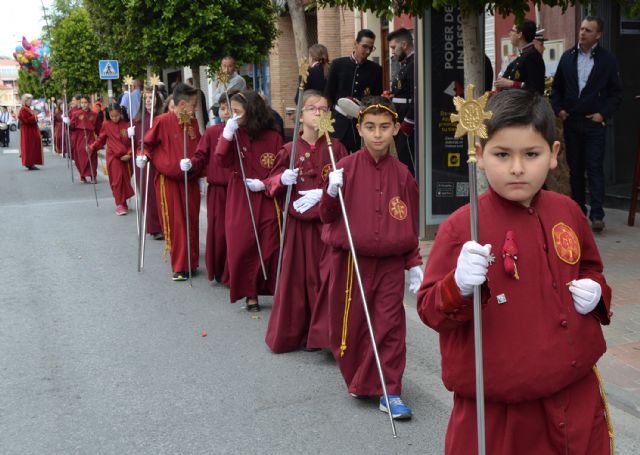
top-left (451, 84), bottom-right (493, 455)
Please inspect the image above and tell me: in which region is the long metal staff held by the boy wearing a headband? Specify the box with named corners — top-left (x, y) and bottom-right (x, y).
top-left (316, 112), bottom-right (398, 438)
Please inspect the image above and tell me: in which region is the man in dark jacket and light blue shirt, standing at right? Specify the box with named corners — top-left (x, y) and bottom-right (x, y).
top-left (551, 16), bottom-right (622, 232)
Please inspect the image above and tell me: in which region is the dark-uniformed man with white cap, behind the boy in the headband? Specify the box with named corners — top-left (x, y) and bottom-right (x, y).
top-left (324, 29), bottom-right (382, 152)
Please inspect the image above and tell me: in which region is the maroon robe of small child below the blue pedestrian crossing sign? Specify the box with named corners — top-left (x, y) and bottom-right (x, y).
top-left (91, 120), bottom-right (134, 205)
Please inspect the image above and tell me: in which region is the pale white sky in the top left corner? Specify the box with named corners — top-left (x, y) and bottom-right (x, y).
top-left (0, 0), bottom-right (53, 58)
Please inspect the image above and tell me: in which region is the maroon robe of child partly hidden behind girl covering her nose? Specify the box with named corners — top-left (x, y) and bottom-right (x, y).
top-left (198, 123), bottom-right (230, 284)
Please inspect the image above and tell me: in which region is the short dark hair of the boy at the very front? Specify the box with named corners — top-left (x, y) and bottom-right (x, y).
top-left (481, 90), bottom-right (556, 147)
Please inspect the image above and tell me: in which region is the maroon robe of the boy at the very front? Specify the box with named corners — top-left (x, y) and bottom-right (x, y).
top-left (418, 190), bottom-right (611, 454)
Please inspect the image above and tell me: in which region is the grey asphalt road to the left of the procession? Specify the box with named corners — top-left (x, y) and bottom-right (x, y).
top-left (0, 141), bottom-right (640, 454)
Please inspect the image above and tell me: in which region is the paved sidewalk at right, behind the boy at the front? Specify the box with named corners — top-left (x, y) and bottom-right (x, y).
top-left (405, 209), bottom-right (640, 418)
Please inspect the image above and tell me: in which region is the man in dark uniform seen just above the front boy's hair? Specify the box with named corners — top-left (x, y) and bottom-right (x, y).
top-left (495, 19), bottom-right (545, 95)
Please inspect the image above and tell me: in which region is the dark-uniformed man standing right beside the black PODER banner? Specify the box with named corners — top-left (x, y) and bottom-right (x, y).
top-left (388, 28), bottom-right (417, 177)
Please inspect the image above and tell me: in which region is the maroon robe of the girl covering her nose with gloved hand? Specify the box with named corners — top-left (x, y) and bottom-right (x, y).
top-left (214, 128), bottom-right (282, 303)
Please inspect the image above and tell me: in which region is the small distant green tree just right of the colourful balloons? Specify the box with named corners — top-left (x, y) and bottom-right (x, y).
top-left (51, 8), bottom-right (105, 93)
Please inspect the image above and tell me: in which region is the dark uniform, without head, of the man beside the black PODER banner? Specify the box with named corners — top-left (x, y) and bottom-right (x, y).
top-left (391, 52), bottom-right (416, 177)
